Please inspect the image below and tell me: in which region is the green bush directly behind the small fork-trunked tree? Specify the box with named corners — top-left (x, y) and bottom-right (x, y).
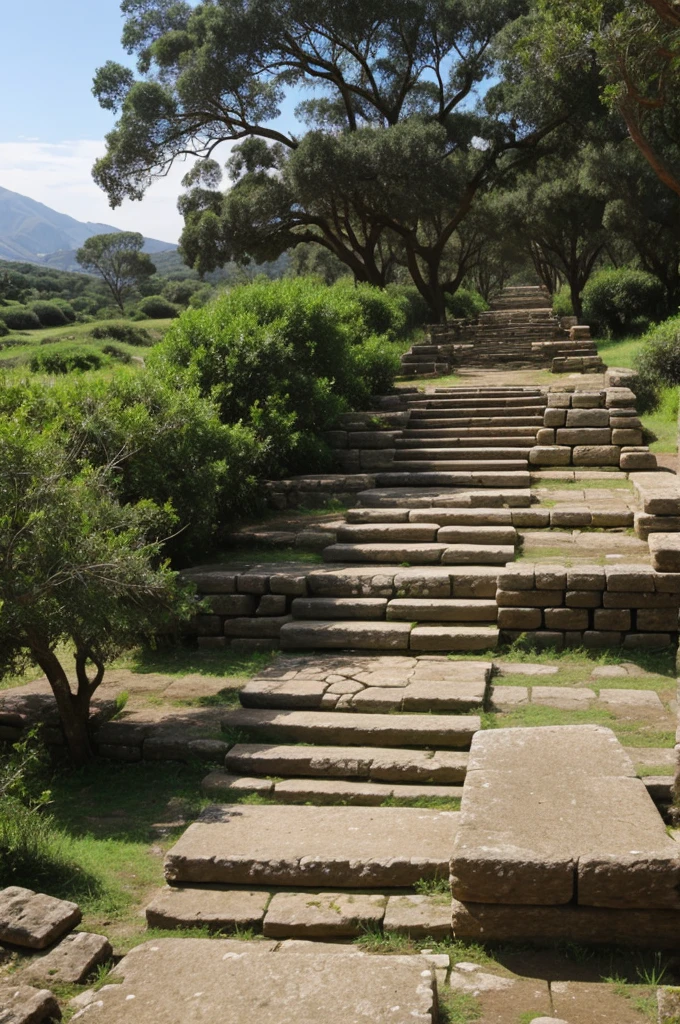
top-left (0, 370), bottom-right (260, 565)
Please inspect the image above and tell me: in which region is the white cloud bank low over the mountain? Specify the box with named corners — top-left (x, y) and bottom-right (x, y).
top-left (0, 139), bottom-right (233, 242)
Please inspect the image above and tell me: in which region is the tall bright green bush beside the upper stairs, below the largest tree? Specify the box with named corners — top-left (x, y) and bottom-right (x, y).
top-left (155, 279), bottom-right (406, 474)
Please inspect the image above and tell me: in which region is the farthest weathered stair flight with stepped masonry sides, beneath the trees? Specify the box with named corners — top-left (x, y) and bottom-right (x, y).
top-left (401, 287), bottom-right (603, 379)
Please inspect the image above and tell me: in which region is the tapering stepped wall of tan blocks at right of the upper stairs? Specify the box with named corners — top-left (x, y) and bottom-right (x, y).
top-left (529, 387), bottom-right (656, 470)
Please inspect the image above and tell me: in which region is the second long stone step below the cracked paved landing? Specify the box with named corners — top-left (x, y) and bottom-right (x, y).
top-left (216, 741), bottom-right (468, 778)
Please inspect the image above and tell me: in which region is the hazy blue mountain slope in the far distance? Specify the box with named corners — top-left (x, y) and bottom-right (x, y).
top-left (0, 186), bottom-right (177, 270)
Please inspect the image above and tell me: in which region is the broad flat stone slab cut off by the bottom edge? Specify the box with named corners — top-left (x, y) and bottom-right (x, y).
top-left (70, 939), bottom-right (436, 1024)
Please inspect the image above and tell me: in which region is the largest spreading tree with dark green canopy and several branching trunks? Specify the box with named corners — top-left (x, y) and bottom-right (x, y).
top-left (94, 0), bottom-right (585, 318)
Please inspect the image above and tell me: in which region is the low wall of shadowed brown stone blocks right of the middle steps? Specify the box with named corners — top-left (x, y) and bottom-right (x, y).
top-left (496, 564), bottom-right (680, 648)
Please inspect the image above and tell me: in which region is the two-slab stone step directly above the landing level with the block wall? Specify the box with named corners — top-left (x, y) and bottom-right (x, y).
top-left (323, 540), bottom-right (515, 565)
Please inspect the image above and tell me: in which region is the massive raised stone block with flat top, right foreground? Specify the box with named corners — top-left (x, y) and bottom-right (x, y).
top-left (451, 726), bottom-right (680, 948)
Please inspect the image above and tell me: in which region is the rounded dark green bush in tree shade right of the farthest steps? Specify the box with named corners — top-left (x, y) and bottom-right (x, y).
top-left (583, 267), bottom-right (664, 338)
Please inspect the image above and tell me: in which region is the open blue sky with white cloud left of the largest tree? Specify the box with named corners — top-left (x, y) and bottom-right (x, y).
top-left (0, 0), bottom-right (293, 242)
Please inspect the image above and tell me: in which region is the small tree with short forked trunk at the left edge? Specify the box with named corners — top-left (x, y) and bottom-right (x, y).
top-left (0, 421), bottom-right (192, 764)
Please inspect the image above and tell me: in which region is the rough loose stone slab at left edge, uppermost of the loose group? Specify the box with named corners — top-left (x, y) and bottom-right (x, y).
top-left (0, 886), bottom-right (82, 949)
